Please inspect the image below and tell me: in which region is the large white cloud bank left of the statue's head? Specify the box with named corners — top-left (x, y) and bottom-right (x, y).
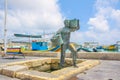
top-left (0, 0), bottom-right (63, 38)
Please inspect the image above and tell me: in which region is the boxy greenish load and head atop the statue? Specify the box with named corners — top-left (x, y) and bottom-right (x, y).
top-left (64, 19), bottom-right (80, 32)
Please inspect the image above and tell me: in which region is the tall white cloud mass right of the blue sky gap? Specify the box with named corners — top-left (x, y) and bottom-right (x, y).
top-left (85, 0), bottom-right (120, 44)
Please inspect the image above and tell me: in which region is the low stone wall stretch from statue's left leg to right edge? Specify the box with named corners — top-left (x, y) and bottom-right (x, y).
top-left (66, 52), bottom-right (120, 60)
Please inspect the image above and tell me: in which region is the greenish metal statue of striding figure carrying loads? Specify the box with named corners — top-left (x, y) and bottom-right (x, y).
top-left (51, 19), bottom-right (80, 67)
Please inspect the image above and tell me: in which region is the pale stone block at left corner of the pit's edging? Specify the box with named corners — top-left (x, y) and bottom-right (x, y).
top-left (2, 65), bottom-right (28, 77)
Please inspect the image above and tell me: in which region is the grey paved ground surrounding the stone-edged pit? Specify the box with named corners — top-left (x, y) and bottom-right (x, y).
top-left (0, 56), bottom-right (120, 80)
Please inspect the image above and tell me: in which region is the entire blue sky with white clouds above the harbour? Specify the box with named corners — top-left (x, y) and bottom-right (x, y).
top-left (0, 0), bottom-right (120, 44)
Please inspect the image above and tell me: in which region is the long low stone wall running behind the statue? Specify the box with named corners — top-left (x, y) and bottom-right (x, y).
top-left (0, 52), bottom-right (120, 60)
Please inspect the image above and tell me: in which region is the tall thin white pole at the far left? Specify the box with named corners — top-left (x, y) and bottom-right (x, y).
top-left (4, 0), bottom-right (7, 54)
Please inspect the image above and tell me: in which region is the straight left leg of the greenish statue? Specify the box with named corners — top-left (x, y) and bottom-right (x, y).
top-left (60, 44), bottom-right (66, 67)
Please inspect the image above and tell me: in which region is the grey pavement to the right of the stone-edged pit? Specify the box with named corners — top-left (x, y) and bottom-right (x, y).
top-left (74, 60), bottom-right (120, 80)
